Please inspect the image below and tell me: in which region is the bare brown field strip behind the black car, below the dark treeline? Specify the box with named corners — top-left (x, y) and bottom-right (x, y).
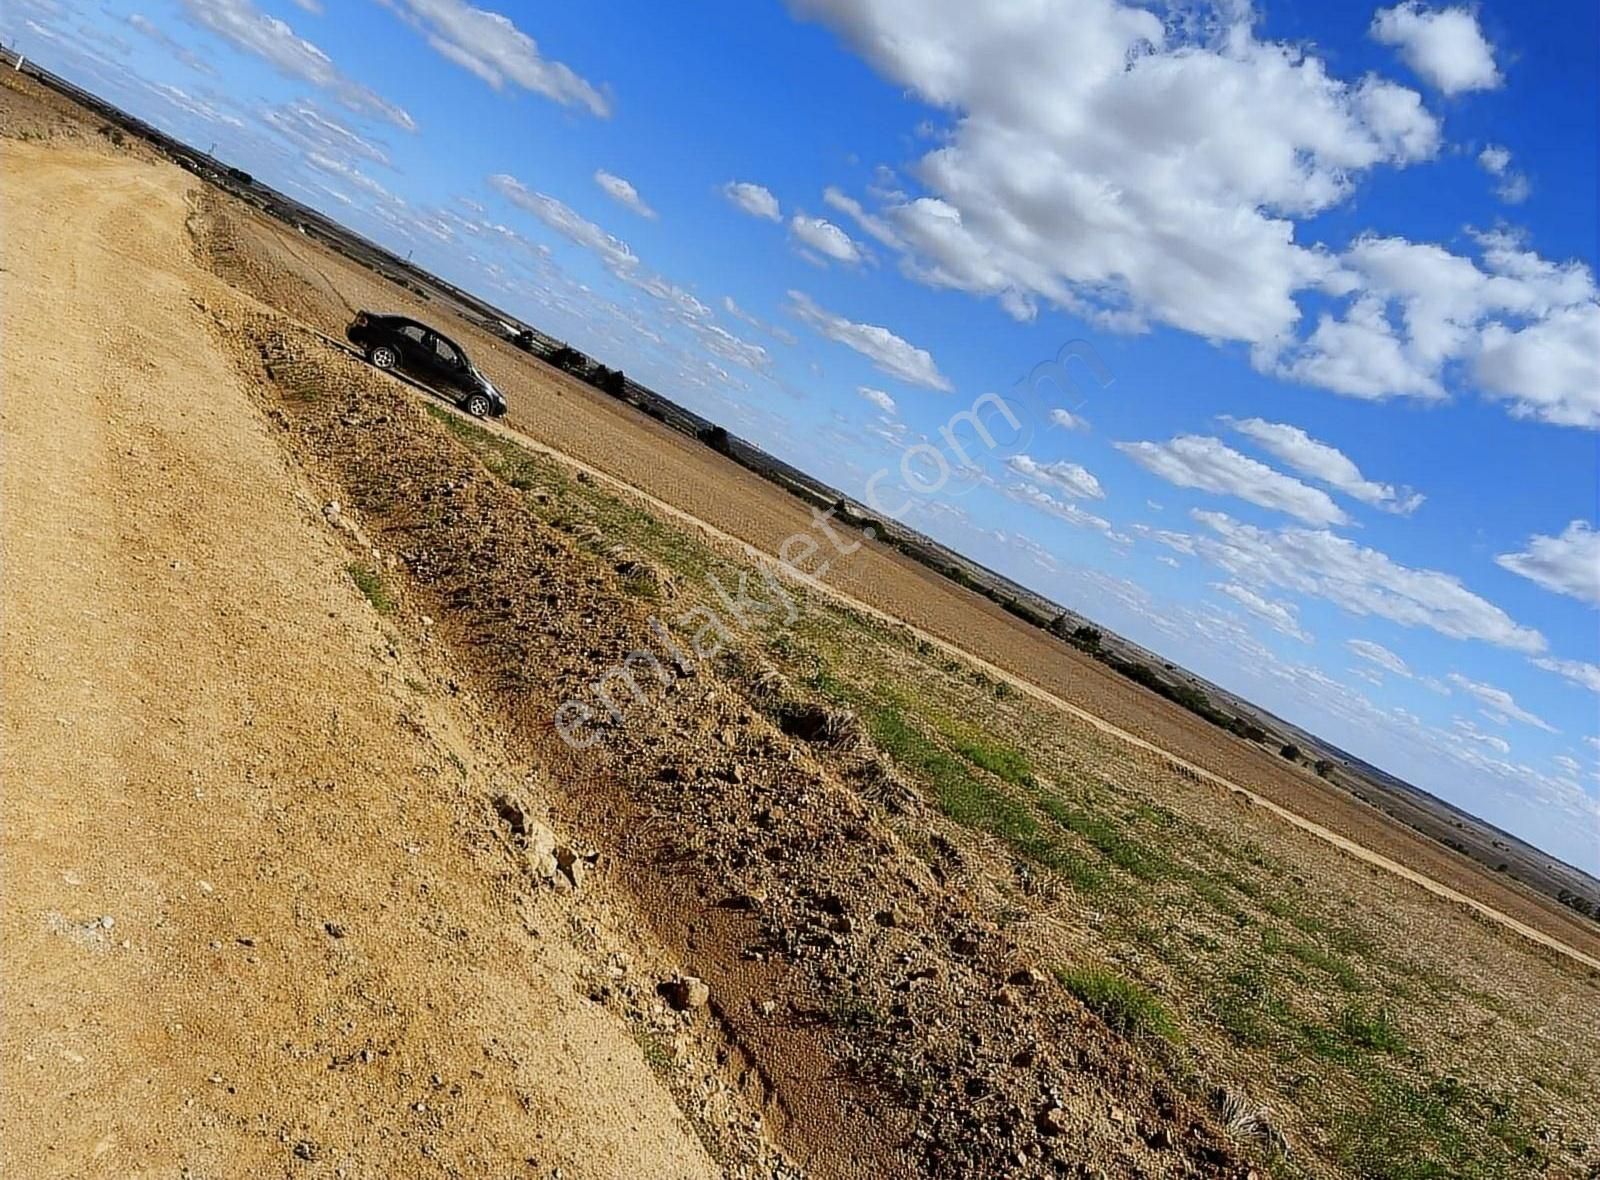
top-left (187, 179), bottom-right (1600, 967)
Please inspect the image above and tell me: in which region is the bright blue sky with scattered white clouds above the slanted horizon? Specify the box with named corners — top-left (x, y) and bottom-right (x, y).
top-left (12, 0), bottom-right (1600, 871)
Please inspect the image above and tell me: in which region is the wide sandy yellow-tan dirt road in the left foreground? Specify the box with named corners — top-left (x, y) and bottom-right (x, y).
top-left (0, 142), bottom-right (720, 1180)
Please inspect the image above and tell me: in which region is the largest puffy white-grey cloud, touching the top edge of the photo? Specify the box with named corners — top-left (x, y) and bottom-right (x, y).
top-left (795, 0), bottom-right (1440, 344)
